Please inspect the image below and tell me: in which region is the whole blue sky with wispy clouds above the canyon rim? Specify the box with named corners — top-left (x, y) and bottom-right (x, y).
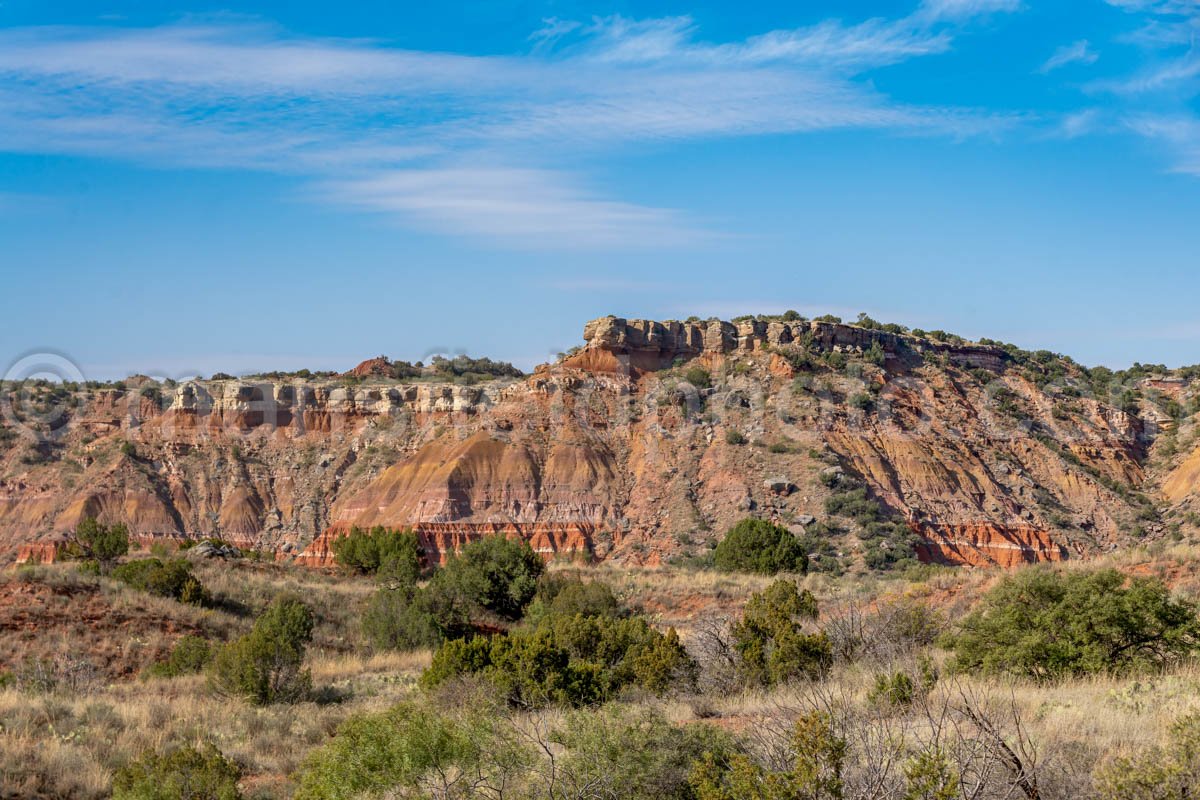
top-left (0, 0), bottom-right (1200, 378)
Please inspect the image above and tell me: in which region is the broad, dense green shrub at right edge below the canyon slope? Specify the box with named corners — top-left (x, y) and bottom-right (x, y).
top-left (949, 567), bottom-right (1200, 680)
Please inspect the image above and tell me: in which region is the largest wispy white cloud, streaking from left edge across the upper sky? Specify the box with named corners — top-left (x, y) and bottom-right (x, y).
top-left (0, 0), bottom-right (1018, 247)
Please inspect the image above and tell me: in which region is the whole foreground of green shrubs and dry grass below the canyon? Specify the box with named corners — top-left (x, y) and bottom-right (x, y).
top-left (7, 527), bottom-right (1200, 800)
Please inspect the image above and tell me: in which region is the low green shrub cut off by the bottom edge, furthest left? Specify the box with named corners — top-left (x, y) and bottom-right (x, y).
top-left (113, 744), bottom-right (241, 800)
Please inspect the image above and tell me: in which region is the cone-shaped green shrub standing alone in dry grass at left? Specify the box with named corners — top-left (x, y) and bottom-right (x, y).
top-left (209, 595), bottom-right (313, 705)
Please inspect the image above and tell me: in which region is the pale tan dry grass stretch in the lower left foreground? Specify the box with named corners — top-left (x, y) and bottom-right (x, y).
top-left (0, 652), bottom-right (428, 798)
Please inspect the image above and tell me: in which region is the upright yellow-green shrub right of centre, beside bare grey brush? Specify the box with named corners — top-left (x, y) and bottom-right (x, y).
top-left (733, 581), bottom-right (833, 686)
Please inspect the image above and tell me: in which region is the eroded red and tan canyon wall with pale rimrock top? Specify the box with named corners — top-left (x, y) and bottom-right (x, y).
top-left (0, 315), bottom-right (1200, 566)
